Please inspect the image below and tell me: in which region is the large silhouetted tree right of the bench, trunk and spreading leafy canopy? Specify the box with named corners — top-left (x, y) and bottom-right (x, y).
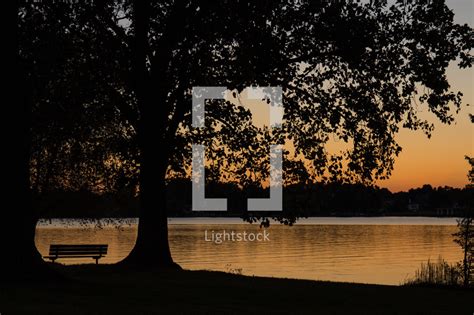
top-left (15, 0), bottom-right (474, 272)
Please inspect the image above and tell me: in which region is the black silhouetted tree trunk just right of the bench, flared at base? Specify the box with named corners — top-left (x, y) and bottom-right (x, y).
top-left (122, 0), bottom-right (179, 269)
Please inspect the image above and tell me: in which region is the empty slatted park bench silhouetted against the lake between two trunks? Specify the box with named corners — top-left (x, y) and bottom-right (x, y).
top-left (44, 244), bottom-right (109, 264)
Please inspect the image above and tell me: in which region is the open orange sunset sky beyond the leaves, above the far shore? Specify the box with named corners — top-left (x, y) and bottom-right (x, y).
top-left (235, 0), bottom-right (474, 192)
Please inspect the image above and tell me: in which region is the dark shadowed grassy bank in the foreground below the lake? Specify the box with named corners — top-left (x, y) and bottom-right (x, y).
top-left (0, 265), bottom-right (474, 315)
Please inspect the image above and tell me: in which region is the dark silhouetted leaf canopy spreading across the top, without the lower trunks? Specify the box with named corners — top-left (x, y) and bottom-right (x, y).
top-left (19, 0), bottom-right (474, 264)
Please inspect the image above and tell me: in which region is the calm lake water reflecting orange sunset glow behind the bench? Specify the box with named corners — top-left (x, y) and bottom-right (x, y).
top-left (36, 217), bottom-right (462, 284)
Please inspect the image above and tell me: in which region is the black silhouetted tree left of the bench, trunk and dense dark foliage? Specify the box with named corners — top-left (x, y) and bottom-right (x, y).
top-left (8, 2), bottom-right (136, 280)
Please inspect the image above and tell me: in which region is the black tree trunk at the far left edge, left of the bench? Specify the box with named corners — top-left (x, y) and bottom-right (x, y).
top-left (0, 2), bottom-right (55, 282)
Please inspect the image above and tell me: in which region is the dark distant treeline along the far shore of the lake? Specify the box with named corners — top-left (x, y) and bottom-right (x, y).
top-left (35, 179), bottom-right (474, 218)
